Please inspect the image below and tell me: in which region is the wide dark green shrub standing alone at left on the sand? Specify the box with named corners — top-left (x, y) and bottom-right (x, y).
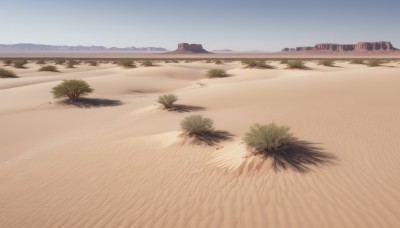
top-left (52, 79), bottom-right (93, 101)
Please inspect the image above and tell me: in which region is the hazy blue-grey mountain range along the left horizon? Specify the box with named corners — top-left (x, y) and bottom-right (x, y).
top-left (0, 43), bottom-right (167, 51)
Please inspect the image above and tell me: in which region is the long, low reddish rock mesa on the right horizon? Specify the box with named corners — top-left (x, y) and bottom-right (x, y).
top-left (282, 41), bottom-right (398, 52)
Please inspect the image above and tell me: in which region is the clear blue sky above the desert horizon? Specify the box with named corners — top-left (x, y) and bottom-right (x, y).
top-left (0, 0), bottom-right (400, 51)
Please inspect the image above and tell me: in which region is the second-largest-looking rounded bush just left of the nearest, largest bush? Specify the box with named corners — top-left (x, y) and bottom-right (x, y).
top-left (181, 115), bottom-right (214, 137)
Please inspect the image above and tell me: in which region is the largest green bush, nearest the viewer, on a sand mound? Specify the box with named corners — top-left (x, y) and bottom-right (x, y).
top-left (243, 123), bottom-right (294, 158)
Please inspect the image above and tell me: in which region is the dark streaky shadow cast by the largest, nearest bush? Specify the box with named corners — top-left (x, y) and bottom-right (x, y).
top-left (256, 140), bottom-right (338, 173)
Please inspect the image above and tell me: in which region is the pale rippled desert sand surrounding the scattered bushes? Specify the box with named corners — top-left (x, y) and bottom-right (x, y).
top-left (0, 61), bottom-right (400, 228)
